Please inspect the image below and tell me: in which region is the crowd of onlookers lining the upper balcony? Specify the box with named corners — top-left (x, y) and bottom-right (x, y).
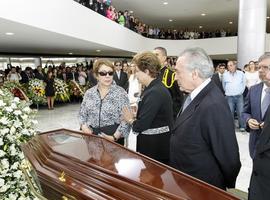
top-left (75, 0), bottom-right (237, 40)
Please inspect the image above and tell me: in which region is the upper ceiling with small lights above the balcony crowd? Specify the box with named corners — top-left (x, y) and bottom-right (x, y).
top-left (113, 0), bottom-right (270, 32)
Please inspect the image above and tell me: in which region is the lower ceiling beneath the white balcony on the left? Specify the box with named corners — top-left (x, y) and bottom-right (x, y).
top-left (0, 18), bottom-right (131, 57)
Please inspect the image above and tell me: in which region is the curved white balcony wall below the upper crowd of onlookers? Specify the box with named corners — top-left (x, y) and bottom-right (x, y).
top-left (0, 0), bottom-right (270, 56)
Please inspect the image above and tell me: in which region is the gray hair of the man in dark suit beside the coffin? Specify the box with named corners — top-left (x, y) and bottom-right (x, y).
top-left (179, 47), bottom-right (214, 80)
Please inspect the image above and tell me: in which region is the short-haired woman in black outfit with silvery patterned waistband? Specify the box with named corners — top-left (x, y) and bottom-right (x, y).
top-left (123, 52), bottom-right (173, 164)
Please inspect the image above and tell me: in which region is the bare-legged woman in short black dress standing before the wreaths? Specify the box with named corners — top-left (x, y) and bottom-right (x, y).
top-left (45, 71), bottom-right (55, 110)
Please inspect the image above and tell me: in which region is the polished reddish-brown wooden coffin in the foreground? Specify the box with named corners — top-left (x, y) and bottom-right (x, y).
top-left (22, 129), bottom-right (238, 200)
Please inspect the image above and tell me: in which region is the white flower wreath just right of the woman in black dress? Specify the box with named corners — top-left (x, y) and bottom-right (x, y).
top-left (54, 78), bottom-right (70, 102)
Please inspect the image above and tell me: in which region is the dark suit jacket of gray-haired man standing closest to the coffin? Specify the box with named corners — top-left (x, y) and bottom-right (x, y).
top-left (170, 81), bottom-right (241, 189)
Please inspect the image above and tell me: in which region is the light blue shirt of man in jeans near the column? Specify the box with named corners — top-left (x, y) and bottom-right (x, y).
top-left (222, 70), bottom-right (246, 96)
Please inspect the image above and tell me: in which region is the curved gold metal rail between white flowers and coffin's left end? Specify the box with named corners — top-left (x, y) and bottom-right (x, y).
top-left (21, 161), bottom-right (48, 200)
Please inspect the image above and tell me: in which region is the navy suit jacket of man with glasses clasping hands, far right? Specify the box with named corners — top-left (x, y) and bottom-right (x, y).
top-left (242, 83), bottom-right (263, 158)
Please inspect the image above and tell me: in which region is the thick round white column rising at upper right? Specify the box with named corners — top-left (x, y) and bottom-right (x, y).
top-left (237, 0), bottom-right (267, 69)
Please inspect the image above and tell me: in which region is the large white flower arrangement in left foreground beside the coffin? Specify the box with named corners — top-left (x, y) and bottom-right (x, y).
top-left (0, 89), bottom-right (36, 200)
